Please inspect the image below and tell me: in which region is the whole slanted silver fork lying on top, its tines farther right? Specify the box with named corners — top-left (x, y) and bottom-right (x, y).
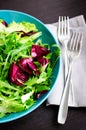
top-left (58, 32), bottom-right (82, 124)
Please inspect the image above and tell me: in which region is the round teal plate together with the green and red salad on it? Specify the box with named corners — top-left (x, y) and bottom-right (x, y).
top-left (0, 10), bottom-right (60, 123)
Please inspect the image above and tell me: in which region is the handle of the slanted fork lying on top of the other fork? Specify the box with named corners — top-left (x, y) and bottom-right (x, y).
top-left (58, 65), bottom-right (71, 124)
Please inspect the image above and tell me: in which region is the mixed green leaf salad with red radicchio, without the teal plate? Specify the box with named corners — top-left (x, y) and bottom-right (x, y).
top-left (0, 19), bottom-right (60, 118)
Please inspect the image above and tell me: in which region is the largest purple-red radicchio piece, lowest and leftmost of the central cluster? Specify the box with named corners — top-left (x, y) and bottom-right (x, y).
top-left (9, 62), bottom-right (29, 86)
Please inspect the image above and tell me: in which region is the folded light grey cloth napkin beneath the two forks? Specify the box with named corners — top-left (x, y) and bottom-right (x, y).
top-left (46, 15), bottom-right (86, 107)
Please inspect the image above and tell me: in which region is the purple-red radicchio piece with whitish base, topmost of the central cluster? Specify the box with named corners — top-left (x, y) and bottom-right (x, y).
top-left (31, 44), bottom-right (50, 58)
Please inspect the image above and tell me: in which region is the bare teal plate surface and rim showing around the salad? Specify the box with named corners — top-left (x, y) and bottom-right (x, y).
top-left (0, 10), bottom-right (60, 123)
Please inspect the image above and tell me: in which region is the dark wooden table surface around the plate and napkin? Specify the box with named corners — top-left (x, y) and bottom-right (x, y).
top-left (0, 0), bottom-right (86, 130)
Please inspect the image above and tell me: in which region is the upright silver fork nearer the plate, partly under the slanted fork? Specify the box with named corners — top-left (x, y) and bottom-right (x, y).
top-left (57, 16), bottom-right (70, 80)
